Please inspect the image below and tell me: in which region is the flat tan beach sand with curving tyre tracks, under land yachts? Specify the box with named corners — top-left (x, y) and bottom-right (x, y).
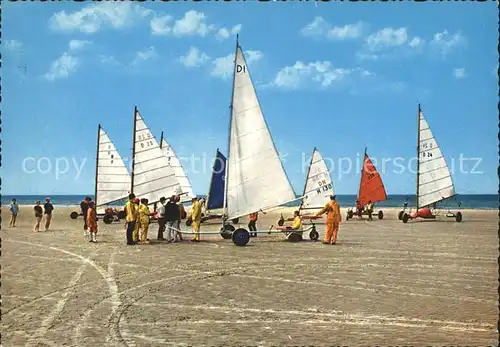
top-left (1, 207), bottom-right (499, 347)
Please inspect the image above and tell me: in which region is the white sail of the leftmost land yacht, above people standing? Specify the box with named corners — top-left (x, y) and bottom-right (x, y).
top-left (95, 126), bottom-right (130, 211)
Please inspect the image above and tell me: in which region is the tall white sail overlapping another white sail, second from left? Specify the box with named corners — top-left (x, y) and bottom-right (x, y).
top-left (133, 110), bottom-right (181, 204)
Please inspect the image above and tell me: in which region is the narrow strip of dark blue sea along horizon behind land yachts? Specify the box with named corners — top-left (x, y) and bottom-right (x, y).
top-left (1, 194), bottom-right (500, 210)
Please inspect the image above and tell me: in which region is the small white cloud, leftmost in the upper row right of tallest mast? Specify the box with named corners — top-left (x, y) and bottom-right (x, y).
top-left (300, 17), bottom-right (363, 40)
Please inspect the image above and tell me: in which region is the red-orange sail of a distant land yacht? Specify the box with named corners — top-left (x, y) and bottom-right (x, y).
top-left (358, 153), bottom-right (387, 206)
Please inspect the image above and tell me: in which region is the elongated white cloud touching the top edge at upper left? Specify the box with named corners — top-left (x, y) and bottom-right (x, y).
top-left (49, 2), bottom-right (153, 34)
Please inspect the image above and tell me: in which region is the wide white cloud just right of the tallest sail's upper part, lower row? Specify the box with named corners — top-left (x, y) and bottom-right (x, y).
top-left (272, 61), bottom-right (374, 89)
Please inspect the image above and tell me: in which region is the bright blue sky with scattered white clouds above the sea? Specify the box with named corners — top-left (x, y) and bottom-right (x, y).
top-left (2, 2), bottom-right (498, 195)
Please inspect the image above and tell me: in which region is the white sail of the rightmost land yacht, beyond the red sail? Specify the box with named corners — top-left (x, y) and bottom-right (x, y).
top-left (418, 111), bottom-right (455, 208)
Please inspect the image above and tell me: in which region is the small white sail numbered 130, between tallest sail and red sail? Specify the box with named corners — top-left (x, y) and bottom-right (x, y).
top-left (300, 149), bottom-right (334, 209)
